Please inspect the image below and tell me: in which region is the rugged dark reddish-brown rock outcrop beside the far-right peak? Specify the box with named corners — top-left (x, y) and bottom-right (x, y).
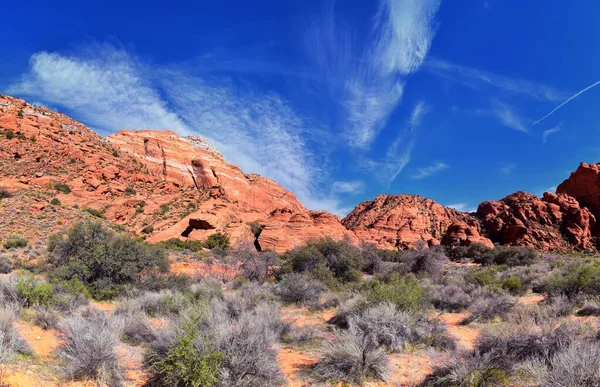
top-left (477, 191), bottom-right (596, 250)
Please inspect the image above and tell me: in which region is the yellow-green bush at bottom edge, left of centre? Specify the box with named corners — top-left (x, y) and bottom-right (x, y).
top-left (148, 324), bottom-right (224, 387)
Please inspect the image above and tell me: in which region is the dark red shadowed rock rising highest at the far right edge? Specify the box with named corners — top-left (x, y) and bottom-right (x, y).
top-left (556, 163), bottom-right (600, 237)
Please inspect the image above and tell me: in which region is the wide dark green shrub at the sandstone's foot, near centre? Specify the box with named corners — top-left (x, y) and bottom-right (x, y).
top-left (282, 238), bottom-right (363, 280)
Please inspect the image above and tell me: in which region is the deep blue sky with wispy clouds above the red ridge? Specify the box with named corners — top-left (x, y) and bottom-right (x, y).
top-left (0, 0), bottom-right (600, 215)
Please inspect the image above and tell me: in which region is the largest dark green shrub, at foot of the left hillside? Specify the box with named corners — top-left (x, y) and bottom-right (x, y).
top-left (47, 222), bottom-right (169, 298)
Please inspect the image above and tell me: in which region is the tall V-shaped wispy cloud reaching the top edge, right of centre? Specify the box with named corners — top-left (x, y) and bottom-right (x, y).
top-left (306, 0), bottom-right (441, 149)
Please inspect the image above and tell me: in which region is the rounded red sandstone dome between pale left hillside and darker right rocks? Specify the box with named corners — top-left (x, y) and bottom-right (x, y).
top-left (342, 194), bottom-right (479, 249)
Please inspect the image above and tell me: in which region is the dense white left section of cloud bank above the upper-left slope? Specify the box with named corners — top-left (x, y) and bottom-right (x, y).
top-left (7, 46), bottom-right (189, 133)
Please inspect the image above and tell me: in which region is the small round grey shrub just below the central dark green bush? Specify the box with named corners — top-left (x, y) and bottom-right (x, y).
top-left (275, 273), bottom-right (325, 304)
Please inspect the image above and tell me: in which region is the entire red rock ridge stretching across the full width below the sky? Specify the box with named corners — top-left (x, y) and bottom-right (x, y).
top-left (0, 96), bottom-right (600, 252)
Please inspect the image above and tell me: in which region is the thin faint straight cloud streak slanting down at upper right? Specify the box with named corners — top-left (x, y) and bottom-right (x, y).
top-left (423, 58), bottom-right (567, 101)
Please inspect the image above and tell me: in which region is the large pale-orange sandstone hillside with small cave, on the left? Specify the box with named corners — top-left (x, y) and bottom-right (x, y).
top-left (0, 97), bottom-right (356, 252)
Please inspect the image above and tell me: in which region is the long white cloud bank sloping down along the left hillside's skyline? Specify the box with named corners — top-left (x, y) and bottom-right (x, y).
top-left (9, 45), bottom-right (340, 213)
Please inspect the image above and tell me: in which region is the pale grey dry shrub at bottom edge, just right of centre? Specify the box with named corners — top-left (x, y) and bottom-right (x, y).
top-left (313, 322), bottom-right (389, 384)
